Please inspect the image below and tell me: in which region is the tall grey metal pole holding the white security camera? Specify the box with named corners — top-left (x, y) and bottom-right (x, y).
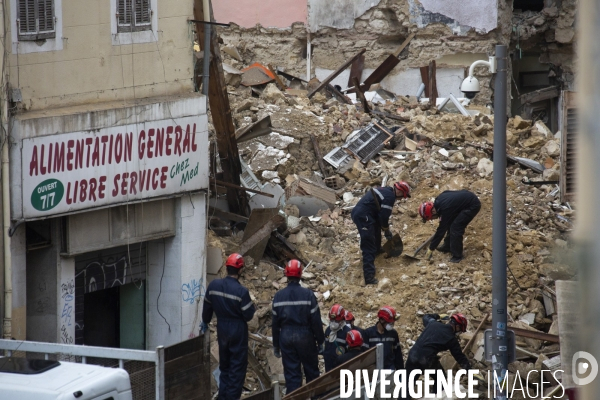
top-left (492, 45), bottom-right (508, 400)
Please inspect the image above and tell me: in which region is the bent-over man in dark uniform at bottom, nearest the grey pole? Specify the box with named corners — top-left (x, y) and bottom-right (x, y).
top-left (406, 313), bottom-right (471, 392)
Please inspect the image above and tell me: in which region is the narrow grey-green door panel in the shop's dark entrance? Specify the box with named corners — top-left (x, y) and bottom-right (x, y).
top-left (119, 280), bottom-right (146, 350)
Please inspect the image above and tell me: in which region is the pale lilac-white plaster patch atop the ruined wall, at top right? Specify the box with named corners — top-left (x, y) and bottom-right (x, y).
top-left (409, 0), bottom-right (498, 34)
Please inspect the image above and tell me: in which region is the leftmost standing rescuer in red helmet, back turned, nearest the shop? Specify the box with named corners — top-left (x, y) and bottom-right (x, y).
top-left (200, 253), bottom-right (256, 400)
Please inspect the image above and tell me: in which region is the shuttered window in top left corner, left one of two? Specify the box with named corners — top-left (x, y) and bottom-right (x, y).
top-left (17, 0), bottom-right (56, 40)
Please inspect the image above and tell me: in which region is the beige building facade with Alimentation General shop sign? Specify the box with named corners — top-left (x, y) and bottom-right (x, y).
top-left (2, 0), bottom-right (208, 349)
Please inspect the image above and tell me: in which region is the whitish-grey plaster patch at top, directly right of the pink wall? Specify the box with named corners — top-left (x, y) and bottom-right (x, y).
top-left (308, 0), bottom-right (381, 32)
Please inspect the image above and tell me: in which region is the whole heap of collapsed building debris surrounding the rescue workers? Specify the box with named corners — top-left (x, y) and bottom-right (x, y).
top-left (204, 54), bottom-right (574, 398)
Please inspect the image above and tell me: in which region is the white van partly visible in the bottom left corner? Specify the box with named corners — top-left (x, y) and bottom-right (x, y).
top-left (0, 357), bottom-right (132, 400)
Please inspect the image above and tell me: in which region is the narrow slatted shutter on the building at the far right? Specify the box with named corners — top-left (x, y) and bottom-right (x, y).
top-left (560, 92), bottom-right (579, 202)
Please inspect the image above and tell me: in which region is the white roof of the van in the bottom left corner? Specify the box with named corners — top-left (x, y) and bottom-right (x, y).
top-left (0, 359), bottom-right (131, 400)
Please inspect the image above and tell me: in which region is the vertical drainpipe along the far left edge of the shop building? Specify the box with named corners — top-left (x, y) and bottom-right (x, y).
top-left (0, 116), bottom-right (12, 339)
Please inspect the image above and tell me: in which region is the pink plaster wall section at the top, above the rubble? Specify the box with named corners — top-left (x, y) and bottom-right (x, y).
top-left (213, 0), bottom-right (307, 28)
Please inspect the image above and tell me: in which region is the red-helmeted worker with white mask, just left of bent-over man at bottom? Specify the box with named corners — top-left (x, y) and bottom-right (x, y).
top-left (365, 306), bottom-right (404, 370)
